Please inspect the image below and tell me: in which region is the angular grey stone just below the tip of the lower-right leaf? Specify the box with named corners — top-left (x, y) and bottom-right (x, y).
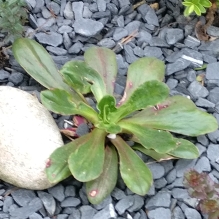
top-left (145, 191), bottom-right (171, 210)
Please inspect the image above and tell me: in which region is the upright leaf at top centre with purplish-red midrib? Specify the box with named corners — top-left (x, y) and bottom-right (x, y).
top-left (84, 47), bottom-right (117, 99)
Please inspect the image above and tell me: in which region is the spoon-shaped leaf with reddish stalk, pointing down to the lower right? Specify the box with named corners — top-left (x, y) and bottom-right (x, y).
top-left (110, 135), bottom-right (153, 195)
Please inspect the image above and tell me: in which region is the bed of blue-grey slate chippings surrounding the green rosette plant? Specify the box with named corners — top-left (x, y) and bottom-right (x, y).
top-left (0, 0), bottom-right (219, 219)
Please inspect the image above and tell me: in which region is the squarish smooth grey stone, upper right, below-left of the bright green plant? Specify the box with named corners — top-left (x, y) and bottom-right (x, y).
top-left (166, 28), bottom-right (184, 45)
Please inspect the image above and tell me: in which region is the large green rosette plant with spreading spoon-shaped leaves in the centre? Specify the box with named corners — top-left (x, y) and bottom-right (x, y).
top-left (12, 38), bottom-right (218, 204)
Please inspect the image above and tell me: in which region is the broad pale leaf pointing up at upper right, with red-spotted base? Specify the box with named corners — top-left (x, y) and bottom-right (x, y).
top-left (120, 57), bottom-right (165, 105)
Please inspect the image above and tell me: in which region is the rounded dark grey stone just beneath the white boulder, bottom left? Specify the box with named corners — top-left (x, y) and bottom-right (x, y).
top-left (11, 189), bottom-right (36, 206)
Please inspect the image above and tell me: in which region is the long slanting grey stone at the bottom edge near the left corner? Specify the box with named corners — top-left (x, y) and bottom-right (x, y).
top-left (9, 198), bottom-right (43, 219)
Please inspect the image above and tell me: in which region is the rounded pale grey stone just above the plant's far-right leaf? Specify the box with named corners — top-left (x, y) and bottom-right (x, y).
top-left (188, 81), bottom-right (209, 98)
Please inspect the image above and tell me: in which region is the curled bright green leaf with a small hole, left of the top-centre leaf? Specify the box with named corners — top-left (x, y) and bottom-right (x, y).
top-left (60, 61), bottom-right (104, 101)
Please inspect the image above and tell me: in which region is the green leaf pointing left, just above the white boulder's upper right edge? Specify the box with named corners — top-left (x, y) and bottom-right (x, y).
top-left (40, 89), bottom-right (98, 123)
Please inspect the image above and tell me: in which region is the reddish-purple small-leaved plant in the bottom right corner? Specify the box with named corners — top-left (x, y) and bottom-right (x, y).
top-left (183, 170), bottom-right (219, 219)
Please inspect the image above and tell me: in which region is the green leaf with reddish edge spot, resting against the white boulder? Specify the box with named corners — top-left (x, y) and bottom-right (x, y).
top-left (46, 136), bottom-right (86, 183)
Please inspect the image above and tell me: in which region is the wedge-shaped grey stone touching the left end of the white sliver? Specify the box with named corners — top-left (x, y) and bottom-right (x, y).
top-left (166, 58), bottom-right (191, 75)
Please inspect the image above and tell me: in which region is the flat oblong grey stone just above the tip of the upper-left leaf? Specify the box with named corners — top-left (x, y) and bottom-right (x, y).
top-left (35, 32), bottom-right (63, 47)
